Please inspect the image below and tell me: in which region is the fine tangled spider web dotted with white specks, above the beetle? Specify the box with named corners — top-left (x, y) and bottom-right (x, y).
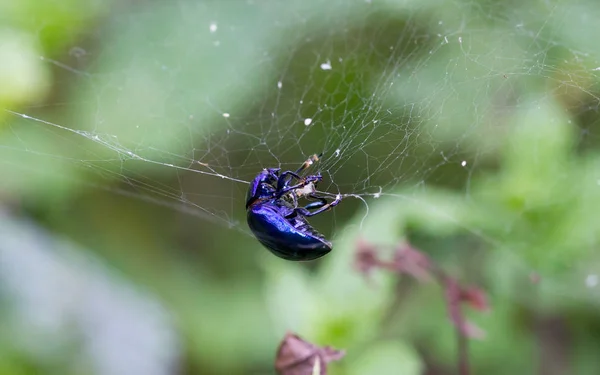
top-left (0, 0), bottom-right (600, 294)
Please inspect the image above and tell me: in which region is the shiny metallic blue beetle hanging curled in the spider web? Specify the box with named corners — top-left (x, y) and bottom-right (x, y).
top-left (246, 155), bottom-right (342, 261)
